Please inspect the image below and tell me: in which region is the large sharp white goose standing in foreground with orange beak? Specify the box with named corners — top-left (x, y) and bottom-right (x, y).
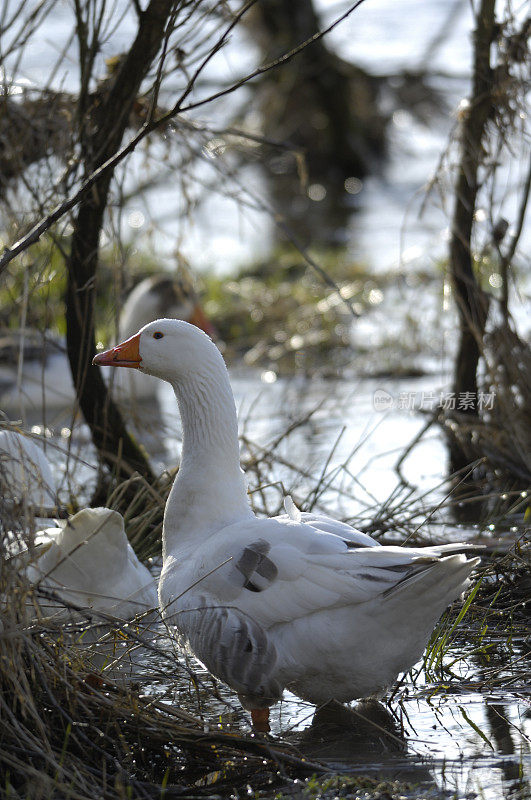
top-left (94, 319), bottom-right (478, 730)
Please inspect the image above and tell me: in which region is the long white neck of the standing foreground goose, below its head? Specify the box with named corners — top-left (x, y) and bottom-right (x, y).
top-left (163, 354), bottom-right (253, 557)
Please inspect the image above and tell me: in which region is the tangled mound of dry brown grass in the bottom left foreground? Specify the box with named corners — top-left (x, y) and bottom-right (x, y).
top-left (0, 504), bottom-right (328, 800)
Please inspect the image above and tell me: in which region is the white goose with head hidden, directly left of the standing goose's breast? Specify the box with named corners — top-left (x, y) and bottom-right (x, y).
top-left (26, 508), bottom-right (158, 620)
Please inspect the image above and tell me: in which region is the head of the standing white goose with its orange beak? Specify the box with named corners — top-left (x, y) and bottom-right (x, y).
top-left (92, 319), bottom-right (223, 384)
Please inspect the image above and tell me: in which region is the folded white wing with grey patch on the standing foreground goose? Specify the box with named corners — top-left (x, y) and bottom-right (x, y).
top-left (168, 518), bottom-right (476, 630)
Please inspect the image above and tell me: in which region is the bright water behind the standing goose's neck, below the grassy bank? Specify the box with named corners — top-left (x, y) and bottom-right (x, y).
top-left (20, 360), bottom-right (447, 516)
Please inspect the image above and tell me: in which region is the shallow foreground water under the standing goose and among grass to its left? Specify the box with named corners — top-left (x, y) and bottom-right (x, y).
top-left (83, 608), bottom-right (531, 800)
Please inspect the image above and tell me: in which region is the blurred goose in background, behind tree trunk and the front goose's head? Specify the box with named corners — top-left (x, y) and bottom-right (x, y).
top-left (0, 270), bottom-right (213, 413)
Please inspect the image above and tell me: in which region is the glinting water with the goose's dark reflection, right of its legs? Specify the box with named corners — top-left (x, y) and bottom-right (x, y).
top-left (278, 694), bottom-right (531, 800)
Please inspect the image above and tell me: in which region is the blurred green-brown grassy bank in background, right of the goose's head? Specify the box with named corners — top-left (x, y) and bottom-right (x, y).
top-left (202, 258), bottom-right (440, 377)
